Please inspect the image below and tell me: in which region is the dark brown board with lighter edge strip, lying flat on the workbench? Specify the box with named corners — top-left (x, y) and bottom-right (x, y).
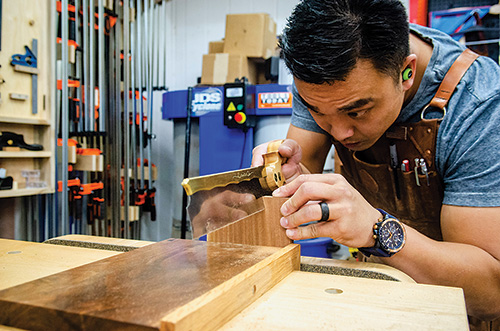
top-left (0, 240), bottom-right (300, 330)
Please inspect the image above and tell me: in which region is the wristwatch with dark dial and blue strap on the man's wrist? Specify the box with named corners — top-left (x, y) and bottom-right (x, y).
top-left (359, 209), bottom-right (406, 257)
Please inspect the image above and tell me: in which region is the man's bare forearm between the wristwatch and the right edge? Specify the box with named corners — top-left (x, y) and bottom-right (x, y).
top-left (384, 226), bottom-right (500, 320)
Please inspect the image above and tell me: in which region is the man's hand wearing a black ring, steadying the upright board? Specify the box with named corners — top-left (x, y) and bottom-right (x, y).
top-left (273, 174), bottom-right (381, 247)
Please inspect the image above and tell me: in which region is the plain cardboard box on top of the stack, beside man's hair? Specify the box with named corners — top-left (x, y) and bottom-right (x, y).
top-left (224, 13), bottom-right (277, 59)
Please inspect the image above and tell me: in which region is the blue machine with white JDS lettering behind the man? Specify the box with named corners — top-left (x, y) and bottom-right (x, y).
top-left (162, 84), bottom-right (292, 176)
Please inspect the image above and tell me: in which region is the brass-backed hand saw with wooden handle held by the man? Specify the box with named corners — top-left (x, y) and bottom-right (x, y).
top-left (182, 140), bottom-right (285, 238)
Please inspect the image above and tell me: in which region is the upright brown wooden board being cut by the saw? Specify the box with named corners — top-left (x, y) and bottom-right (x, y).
top-left (207, 196), bottom-right (293, 247)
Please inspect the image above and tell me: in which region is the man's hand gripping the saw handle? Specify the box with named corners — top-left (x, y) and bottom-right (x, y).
top-left (252, 139), bottom-right (308, 183)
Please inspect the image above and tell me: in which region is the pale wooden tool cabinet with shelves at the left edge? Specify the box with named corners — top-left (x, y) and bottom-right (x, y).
top-left (0, 0), bottom-right (56, 198)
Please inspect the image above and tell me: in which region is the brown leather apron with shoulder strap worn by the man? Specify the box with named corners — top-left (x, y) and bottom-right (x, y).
top-left (333, 50), bottom-right (500, 330)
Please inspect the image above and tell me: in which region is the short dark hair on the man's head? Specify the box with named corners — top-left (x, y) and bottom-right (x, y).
top-left (280, 0), bottom-right (410, 84)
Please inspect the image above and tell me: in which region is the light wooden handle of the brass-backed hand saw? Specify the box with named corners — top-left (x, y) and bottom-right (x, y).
top-left (259, 139), bottom-right (286, 191)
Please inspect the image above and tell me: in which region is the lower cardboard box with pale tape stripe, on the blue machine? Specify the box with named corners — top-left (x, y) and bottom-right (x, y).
top-left (201, 53), bottom-right (257, 85)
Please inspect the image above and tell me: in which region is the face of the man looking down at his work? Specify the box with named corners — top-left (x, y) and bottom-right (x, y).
top-left (295, 60), bottom-right (404, 151)
